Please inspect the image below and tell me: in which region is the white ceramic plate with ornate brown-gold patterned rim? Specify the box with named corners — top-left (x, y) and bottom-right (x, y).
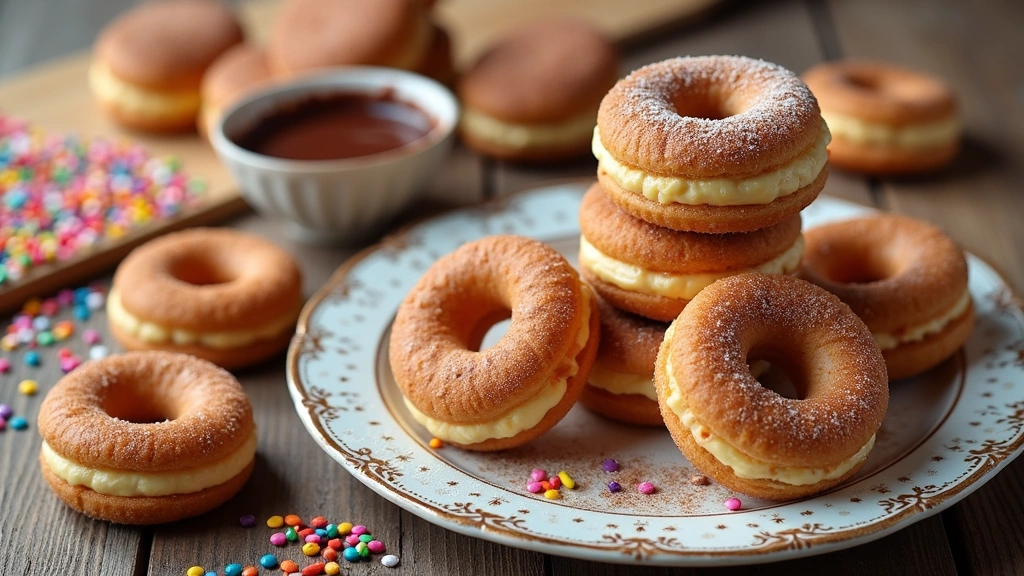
top-left (288, 183), bottom-right (1024, 566)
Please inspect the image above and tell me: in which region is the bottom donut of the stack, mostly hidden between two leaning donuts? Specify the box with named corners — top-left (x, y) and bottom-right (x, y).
top-left (580, 299), bottom-right (668, 426)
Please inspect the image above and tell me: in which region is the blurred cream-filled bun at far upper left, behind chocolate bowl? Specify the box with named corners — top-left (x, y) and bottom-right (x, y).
top-left (89, 0), bottom-right (243, 132)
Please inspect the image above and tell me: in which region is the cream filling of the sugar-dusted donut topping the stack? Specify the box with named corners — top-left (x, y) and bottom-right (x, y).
top-left (593, 122), bottom-right (831, 206)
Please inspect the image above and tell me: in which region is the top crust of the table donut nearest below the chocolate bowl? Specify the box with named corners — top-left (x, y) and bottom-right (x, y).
top-left (112, 229), bottom-right (302, 333)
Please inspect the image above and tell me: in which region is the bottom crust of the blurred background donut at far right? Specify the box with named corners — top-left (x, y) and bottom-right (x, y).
top-left (828, 136), bottom-right (959, 174)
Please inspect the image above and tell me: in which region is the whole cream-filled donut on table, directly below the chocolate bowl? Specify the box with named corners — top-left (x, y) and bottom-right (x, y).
top-left (106, 229), bottom-right (302, 368)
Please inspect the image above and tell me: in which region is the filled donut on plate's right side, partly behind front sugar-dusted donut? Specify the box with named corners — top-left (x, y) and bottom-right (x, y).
top-left (801, 215), bottom-right (975, 379)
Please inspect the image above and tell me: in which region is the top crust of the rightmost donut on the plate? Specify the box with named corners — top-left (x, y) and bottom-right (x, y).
top-left (801, 214), bottom-right (968, 336)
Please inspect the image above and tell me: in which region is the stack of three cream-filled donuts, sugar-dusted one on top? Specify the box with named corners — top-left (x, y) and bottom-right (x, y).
top-left (580, 56), bottom-right (829, 425)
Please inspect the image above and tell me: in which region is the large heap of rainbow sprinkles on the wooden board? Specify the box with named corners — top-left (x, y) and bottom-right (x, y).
top-left (0, 114), bottom-right (205, 285)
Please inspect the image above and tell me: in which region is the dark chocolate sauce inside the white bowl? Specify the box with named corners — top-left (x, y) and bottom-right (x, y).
top-left (236, 92), bottom-right (434, 160)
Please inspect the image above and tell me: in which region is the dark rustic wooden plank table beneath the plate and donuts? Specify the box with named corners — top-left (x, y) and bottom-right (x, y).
top-left (0, 0), bottom-right (1024, 576)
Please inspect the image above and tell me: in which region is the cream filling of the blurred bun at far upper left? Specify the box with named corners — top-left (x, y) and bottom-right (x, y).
top-left (89, 61), bottom-right (201, 119)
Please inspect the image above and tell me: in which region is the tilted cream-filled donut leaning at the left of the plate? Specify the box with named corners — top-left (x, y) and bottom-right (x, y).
top-left (389, 236), bottom-right (600, 451)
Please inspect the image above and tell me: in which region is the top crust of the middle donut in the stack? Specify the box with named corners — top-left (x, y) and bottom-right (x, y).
top-left (580, 183), bottom-right (801, 275)
